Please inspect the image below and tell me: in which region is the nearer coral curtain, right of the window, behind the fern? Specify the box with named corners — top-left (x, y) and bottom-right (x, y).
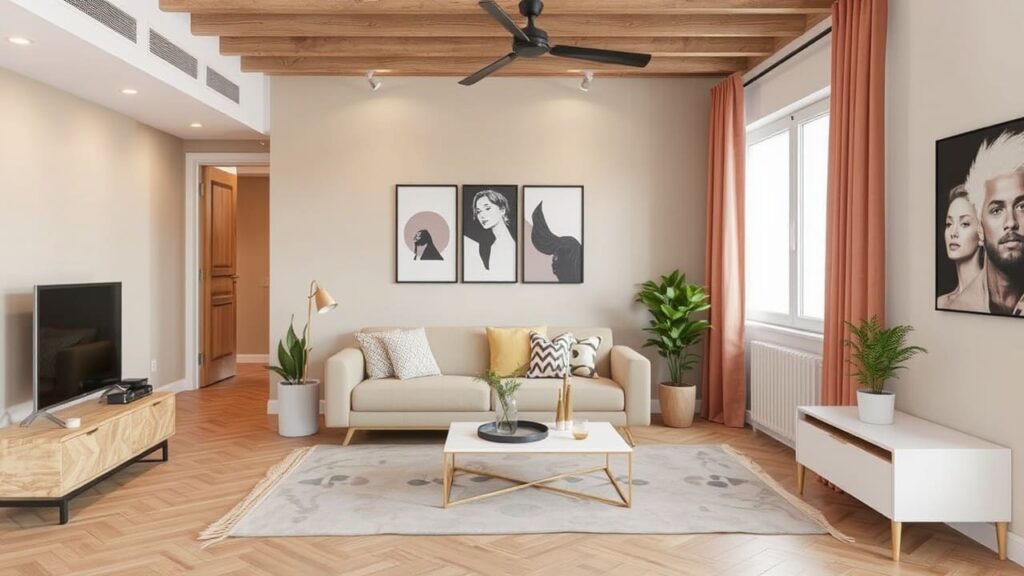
top-left (821, 0), bottom-right (888, 405)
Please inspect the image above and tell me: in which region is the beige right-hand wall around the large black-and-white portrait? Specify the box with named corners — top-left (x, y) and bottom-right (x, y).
top-left (888, 0), bottom-right (1024, 535)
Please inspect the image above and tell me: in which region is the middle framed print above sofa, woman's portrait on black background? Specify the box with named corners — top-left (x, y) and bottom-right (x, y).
top-left (462, 184), bottom-right (519, 283)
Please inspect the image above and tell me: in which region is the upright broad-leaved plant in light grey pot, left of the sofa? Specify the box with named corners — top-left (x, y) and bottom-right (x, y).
top-left (266, 318), bottom-right (319, 437)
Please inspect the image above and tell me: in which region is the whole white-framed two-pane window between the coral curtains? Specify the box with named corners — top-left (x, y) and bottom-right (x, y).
top-left (745, 99), bottom-right (828, 332)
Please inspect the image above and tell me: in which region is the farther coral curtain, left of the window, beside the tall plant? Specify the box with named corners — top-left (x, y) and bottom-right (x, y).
top-left (700, 74), bottom-right (746, 427)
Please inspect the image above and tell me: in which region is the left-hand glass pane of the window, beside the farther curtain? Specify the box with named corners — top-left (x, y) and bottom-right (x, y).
top-left (746, 131), bottom-right (790, 315)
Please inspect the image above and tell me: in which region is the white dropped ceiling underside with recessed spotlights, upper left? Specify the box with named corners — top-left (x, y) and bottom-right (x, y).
top-left (0, 0), bottom-right (266, 139)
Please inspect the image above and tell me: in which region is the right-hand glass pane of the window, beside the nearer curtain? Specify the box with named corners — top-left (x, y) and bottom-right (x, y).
top-left (799, 114), bottom-right (828, 320)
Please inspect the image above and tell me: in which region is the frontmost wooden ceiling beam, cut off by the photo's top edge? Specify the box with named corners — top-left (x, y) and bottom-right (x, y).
top-left (160, 0), bottom-right (833, 15)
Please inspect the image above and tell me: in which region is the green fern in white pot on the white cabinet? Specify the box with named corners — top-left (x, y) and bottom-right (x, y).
top-left (843, 316), bottom-right (928, 424)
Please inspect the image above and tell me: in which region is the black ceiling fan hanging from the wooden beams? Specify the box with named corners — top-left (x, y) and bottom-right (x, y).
top-left (459, 0), bottom-right (650, 86)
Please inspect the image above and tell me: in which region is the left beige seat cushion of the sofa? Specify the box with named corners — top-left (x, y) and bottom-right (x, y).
top-left (352, 376), bottom-right (490, 412)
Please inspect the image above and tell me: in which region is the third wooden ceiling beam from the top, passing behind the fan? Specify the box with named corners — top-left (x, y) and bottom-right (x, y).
top-left (220, 36), bottom-right (775, 57)
